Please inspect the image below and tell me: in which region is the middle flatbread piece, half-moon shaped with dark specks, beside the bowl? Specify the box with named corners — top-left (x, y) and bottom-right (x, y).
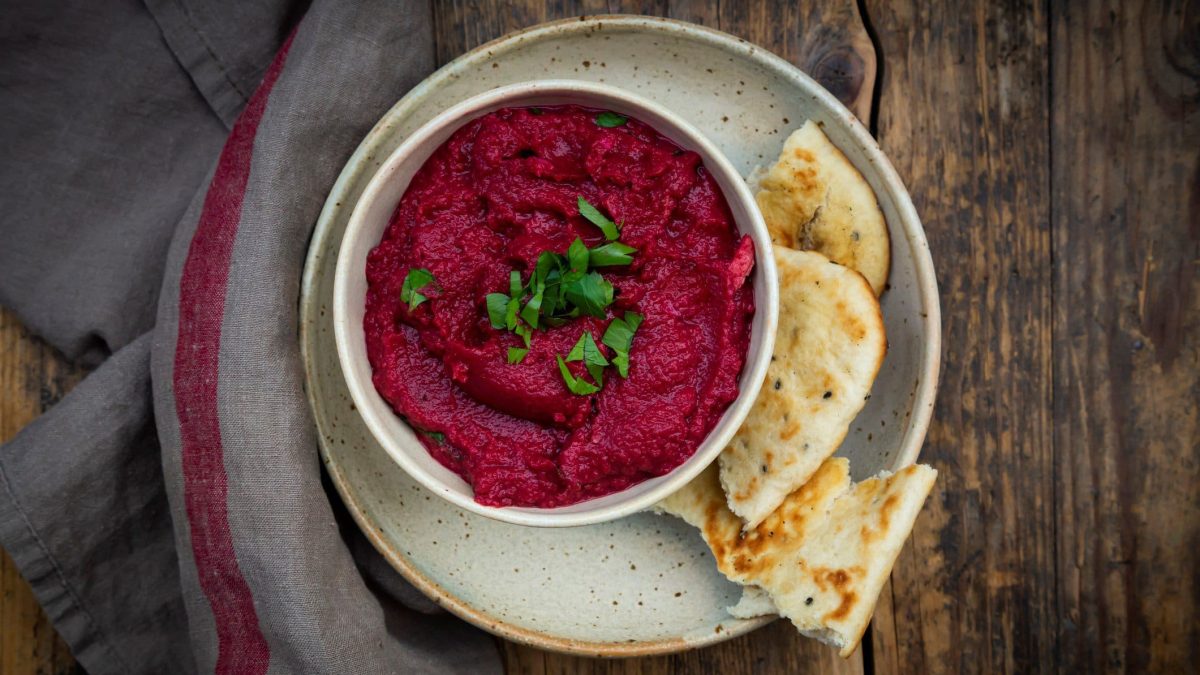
top-left (719, 247), bottom-right (888, 527)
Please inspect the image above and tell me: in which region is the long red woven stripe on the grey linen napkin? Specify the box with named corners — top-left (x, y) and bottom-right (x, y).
top-left (174, 34), bottom-right (294, 675)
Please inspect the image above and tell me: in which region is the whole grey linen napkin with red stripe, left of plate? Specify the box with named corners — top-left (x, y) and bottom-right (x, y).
top-left (0, 0), bottom-right (499, 675)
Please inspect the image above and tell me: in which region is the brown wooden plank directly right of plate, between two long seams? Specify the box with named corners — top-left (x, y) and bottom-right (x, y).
top-left (866, 0), bottom-right (1057, 673)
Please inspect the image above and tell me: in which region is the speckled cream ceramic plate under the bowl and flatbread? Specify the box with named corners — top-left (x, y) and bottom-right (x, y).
top-left (300, 17), bottom-right (940, 656)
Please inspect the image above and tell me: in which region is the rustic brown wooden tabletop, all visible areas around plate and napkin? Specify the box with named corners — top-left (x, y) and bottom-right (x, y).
top-left (0, 0), bottom-right (1200, 675)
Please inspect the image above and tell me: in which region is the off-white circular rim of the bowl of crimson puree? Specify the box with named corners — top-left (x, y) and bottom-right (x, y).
top-left (332, 79), bottom-right (779, 527)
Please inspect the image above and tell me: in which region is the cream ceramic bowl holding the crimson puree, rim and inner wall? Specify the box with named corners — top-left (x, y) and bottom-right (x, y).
top-left (334, 80), bottom-right (779, 527)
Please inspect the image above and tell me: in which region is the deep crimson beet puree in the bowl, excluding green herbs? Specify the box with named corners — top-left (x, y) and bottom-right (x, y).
top-left (364, 106), bottom-right (754, 507)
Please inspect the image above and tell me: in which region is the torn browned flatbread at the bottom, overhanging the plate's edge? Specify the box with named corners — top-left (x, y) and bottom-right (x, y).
top-left (659, 458), bottom-right (937, 657)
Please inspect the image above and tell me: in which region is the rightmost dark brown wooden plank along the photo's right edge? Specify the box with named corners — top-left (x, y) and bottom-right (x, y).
top-left (1051, 1), bottom-right (1200, 673)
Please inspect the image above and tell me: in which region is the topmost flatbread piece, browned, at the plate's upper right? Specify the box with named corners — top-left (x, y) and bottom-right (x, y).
top-left (749, 120), bottom-right (892, 295)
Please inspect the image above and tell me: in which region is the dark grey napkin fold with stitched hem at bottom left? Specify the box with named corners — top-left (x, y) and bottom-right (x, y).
top-left (0, 334), bottom-right (194, 675)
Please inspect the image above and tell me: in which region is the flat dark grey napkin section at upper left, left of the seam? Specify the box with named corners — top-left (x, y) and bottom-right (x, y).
top-left (0, 0), bottom-right (228, 365)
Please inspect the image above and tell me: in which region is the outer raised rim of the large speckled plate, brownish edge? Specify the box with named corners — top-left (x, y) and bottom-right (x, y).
top-left (298, 14), bottom-right (941, 657)
